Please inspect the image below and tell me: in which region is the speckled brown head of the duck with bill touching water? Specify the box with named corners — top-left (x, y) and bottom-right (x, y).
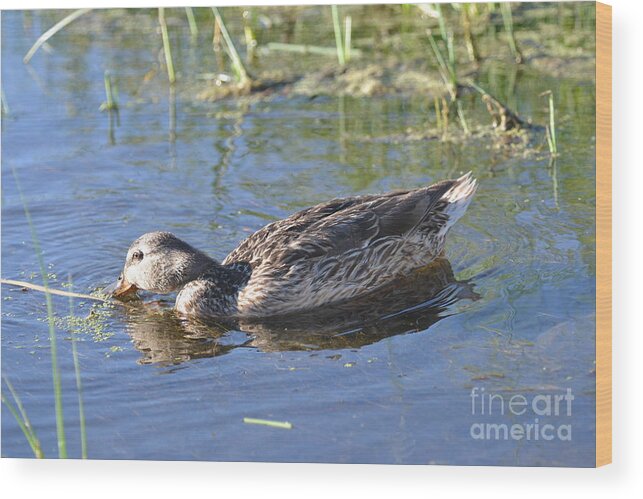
top-left (104, 232), bottom-right (215, 296)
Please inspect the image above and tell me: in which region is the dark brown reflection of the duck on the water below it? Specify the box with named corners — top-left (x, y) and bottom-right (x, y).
top-left (121, 259), bottom-right (478, 364)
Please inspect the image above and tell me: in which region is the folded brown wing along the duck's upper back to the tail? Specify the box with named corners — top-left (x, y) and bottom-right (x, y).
top-left (224, 175), bottom-right (475, 265)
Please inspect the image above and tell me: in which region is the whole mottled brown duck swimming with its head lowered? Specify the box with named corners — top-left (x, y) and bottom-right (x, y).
top-left (105, 172), bottom-right (477, 318)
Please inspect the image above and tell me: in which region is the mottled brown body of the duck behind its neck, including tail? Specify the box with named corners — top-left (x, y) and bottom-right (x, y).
top-left (223, 174), bottom-right (476, 316)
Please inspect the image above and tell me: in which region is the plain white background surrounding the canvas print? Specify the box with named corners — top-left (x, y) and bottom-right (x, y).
top-left (0, 0), bottom-right (643, 499)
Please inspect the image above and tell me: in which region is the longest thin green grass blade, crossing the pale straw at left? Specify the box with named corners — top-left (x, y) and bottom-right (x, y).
top-left (11, 165), bottom-right (67, 458)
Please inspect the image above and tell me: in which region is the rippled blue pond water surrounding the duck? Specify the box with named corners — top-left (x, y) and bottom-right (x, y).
top-left (2, 6), bottom-right (595, 466)
